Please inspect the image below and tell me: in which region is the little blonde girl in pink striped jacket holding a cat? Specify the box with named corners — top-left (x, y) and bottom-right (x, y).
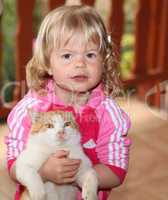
top-left (6, 6), bottom-right (130, 200)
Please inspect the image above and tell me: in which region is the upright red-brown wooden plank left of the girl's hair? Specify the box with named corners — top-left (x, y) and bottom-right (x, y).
top-left (14, 0), bottom-right (35, 100)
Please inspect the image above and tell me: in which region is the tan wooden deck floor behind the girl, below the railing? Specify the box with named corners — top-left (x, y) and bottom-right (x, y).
top-left (0, 97), bottom-right (168, 200)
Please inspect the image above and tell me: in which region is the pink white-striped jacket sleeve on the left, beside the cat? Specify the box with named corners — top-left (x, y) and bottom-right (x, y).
top-left (5, 97), bottom-right (35, 170)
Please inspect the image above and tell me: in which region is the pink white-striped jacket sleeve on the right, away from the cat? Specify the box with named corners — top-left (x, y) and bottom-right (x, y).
top-left (96, 98), bottom-right (131, 182)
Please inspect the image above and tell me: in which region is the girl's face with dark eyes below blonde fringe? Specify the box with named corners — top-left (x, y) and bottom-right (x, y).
top-left (49, 35), bottom-right (103, 94)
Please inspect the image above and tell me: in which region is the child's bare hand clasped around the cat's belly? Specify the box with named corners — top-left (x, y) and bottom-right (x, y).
top-left (39, 150), bottom-right (80, 184)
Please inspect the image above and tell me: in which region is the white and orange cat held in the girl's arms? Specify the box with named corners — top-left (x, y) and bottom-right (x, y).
top-left (16, 110), bottom-right (98, 200)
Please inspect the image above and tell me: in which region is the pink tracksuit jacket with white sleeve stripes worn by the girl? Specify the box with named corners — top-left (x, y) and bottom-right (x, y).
top-left (6, 81), bottom-right (131, 200)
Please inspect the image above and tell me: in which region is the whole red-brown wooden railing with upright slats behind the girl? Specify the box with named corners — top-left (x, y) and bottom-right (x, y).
top-left (0, 0), bottom-right (168, 119)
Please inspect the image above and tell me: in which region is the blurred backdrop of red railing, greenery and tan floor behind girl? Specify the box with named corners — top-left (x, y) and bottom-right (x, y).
top-left (0, 0), bottom-right (168, 200)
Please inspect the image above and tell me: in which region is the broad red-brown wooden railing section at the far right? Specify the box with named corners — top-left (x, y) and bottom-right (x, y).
top-left (131, 0), bottom-right (168, 107)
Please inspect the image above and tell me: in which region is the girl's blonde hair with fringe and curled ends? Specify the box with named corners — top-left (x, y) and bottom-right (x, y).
top-left (26, 5), bottom-right (120, 96)
